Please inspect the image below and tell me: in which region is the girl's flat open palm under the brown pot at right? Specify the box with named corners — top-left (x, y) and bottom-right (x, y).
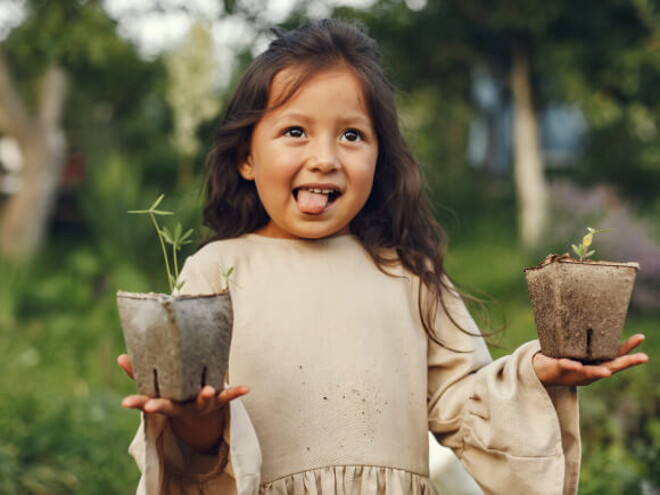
top-left (533, 334), bottom-right (649, 386)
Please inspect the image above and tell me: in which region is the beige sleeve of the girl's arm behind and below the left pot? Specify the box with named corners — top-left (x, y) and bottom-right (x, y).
top-left (129, 254), bottom-right (261, 495)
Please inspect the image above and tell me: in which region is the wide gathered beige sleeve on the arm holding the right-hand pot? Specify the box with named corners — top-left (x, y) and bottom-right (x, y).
top-left (428, 282), bottom-right (580, 495)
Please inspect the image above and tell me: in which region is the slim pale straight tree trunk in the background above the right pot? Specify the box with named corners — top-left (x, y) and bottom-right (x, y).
top-left (511, 45), bottom-right (547, 248)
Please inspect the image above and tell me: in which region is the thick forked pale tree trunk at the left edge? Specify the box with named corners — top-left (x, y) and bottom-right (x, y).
top-left (0, 49), bottom-right (66, 259)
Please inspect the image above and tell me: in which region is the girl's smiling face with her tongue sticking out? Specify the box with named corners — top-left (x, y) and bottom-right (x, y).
top-left (239, 68), bottom-right (378, 239)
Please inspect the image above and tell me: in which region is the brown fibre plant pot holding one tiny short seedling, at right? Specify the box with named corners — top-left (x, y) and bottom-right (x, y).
top-left (525, 254), bottom-right (639, 362)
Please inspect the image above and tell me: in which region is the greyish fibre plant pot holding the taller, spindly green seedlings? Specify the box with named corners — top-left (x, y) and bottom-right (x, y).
top-left (117, 291), bottom-right (233, 402)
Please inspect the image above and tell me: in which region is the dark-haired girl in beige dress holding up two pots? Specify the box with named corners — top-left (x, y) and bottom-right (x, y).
top-left (119, 19), bottom-right (647, 495)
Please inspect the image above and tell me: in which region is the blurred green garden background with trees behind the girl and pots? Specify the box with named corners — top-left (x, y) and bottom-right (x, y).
top-left (0, 0), bottom-right (660, 495)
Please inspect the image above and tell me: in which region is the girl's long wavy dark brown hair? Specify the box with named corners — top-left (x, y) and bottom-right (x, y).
top-left (204, 19), bottom-right (458, 341)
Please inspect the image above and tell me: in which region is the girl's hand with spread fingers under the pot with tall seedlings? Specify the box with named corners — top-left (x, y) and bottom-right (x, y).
top-left (117, 354), bottom-right (250, 452)
